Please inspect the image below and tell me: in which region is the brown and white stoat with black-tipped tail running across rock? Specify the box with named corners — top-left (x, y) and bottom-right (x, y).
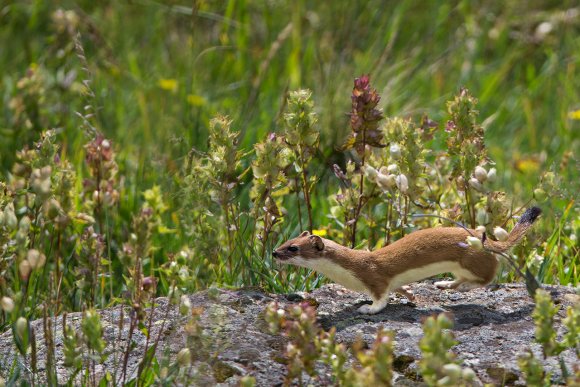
top-left (272, 207), bottom-right (542, 314)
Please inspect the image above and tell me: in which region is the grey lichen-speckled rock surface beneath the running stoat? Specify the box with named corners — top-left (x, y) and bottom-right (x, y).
top-left (0, 282), bottom-right (580, 386)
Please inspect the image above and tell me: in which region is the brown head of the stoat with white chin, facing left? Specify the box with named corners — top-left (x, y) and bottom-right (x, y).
top-left (272, 231), bottom-right (324, 267)
